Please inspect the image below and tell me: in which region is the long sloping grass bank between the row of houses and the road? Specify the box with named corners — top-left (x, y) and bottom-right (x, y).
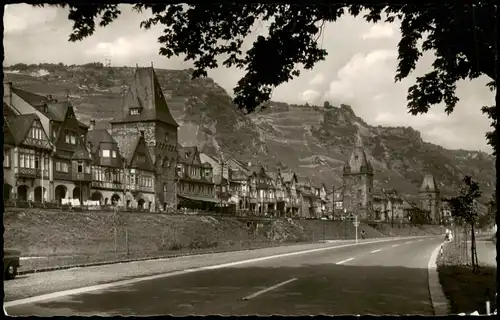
top-left (3, 208), bottom-right (442, 271)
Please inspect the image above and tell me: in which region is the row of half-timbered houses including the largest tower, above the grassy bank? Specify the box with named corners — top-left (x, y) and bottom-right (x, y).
top-left (3, 67), bottom-right (327, 217)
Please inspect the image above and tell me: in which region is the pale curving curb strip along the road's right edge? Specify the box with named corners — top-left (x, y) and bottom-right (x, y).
top-left (427, 244), bottom-right (450, 316)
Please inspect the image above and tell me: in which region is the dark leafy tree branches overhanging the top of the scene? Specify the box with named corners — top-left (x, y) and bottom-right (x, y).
top-left (38, 1), bottom-right (497, 149)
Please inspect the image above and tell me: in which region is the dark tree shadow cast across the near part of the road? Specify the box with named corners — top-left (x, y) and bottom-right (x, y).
top-left (7, 263), bottom-right (433, 316)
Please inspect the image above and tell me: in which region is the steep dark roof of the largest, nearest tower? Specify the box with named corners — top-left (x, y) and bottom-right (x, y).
top-left (111, 67), bottom-right (179, 127)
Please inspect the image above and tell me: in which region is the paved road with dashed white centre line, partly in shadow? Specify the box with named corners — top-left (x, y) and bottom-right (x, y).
top-left (5, 237), bottom-right (442, 316)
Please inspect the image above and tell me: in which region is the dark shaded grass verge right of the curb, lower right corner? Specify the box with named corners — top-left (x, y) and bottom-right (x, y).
top-left (437, 242), bottom-right (497, 314)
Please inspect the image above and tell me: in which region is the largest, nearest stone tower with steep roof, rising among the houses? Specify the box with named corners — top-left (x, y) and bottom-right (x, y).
top-left (111, 66), bottom-right (179, 208)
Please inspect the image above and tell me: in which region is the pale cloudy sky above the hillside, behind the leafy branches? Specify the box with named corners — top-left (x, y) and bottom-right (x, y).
top-left (4, 4), bottom-right (494, 153)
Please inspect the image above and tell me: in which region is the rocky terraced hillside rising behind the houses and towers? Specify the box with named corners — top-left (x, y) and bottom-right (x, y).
top-left (4, 63), bottom-right (495, 200)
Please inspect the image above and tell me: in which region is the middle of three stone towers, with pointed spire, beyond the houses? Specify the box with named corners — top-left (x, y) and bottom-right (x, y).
top-left (343, 135), bottom-right (373, 219)
